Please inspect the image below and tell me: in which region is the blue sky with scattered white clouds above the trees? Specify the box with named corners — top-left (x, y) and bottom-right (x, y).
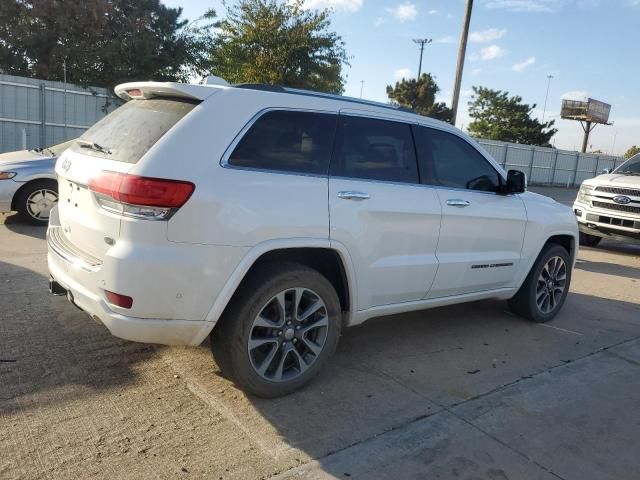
top-left (165, 0), bottom-right (640, 154)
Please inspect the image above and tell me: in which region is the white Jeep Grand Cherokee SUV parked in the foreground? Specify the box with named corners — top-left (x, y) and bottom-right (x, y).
top-left (48, 82), bottom-right (578, 396)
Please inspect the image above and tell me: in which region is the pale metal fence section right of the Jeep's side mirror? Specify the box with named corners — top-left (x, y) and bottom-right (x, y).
top-left (478, 140), bottom-right (624, 187)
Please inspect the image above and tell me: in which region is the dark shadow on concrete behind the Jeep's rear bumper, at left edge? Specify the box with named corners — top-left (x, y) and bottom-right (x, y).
top-left (0, 260), bottom-right (157, 416)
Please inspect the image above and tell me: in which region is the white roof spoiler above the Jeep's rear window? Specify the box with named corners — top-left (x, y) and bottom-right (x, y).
top-left (114, 82), bottom-right (228, 101)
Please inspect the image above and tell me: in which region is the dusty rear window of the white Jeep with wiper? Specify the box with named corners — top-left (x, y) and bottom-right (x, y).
top-left (72, 98), bottom-right (198, 163)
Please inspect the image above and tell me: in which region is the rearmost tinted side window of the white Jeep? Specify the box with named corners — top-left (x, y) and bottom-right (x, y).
top-left (229, 110), bottom-right (337, 175)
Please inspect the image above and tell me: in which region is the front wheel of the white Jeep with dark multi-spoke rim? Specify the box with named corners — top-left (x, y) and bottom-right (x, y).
top-left (509, 244), bottom-right (571, 323)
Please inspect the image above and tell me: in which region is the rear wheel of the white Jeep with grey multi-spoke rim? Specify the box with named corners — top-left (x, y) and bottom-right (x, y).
top-left (211, 263), bottom-right (341, 397)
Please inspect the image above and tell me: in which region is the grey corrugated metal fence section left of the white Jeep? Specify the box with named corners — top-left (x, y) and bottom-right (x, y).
top-left (0, 75), bottom-right (120, 152)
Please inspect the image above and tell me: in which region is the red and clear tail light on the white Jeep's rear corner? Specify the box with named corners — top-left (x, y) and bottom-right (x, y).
top-left (89, 172), bottom-right (195, 220)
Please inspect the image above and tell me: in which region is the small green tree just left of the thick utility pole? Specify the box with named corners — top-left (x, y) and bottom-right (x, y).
top-left (387, 73), bottom-right (453, 122)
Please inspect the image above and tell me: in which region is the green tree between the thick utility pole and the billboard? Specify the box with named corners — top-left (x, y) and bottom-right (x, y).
top-left (469, 87), bottom-right (558, 147)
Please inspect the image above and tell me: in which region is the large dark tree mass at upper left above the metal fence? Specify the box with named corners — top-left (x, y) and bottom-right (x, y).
top-left (0, 0), bottom-right (208, 88)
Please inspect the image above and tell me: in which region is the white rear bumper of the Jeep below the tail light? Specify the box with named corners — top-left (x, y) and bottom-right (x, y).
top-left (47, 204), bottom-right (244, 345)
